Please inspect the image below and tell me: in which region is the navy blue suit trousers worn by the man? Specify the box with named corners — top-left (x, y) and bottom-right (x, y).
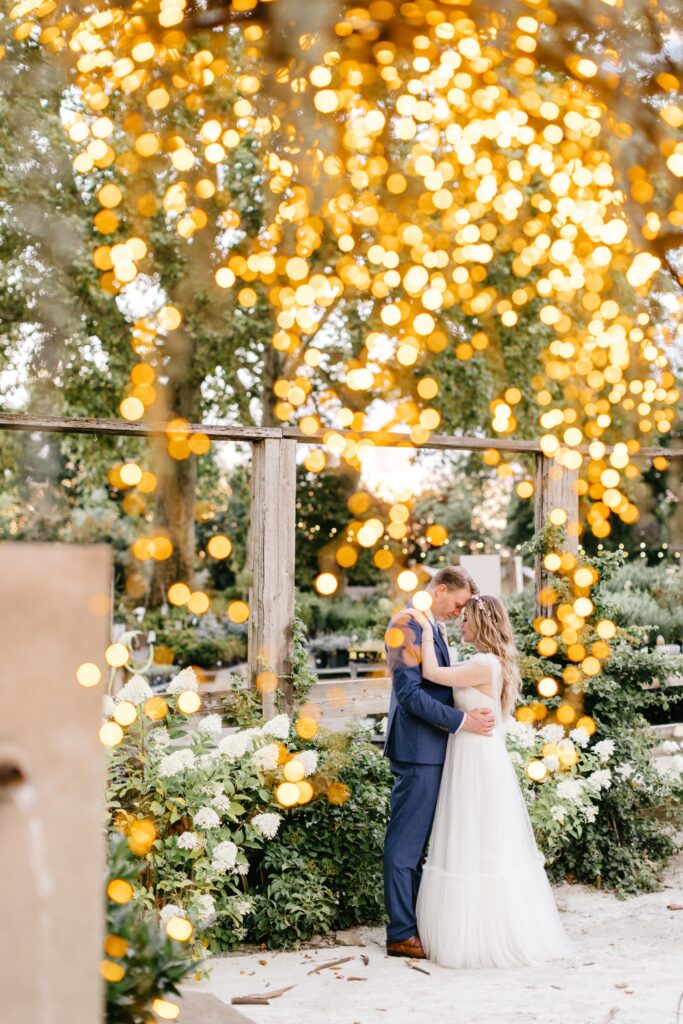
top-left (384, 760), bottom-right (443, 942)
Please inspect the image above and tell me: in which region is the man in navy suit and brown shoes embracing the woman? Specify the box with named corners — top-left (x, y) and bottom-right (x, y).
top-left (384, 565), bottom-right (494, 959)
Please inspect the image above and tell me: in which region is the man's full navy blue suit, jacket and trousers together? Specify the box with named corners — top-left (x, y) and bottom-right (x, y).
top-left (384, 609), bottom-right (465, 942)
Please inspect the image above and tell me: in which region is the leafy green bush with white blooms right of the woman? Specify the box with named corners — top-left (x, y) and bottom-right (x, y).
top-left (510, 554), bottom-right (683, 893)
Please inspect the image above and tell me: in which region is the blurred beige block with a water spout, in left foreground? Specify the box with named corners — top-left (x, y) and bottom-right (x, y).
top-left (0, 544), bottom-right (112, 1024)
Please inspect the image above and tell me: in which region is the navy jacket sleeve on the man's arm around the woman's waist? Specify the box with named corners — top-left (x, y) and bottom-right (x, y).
top-left (386, 615), bottom-right (465, 732)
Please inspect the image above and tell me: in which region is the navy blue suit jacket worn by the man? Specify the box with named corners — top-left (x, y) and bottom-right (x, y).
top-left (384, 605), bottom-right (465, 765)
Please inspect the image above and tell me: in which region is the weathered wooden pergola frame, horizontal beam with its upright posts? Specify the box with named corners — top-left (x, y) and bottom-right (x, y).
top-left (0, 413), bottom-right (683, 717)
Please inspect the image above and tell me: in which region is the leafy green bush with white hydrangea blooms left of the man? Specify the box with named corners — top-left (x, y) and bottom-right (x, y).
top-left (106, 670), bottom-right (389, 951)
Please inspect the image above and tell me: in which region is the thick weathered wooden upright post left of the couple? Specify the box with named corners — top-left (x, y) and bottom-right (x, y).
top-left (249, 438), bottom-right (297, 718)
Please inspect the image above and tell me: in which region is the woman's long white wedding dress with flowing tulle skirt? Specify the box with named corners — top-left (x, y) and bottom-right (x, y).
top-left (417, 653), bottom-right (571, 968)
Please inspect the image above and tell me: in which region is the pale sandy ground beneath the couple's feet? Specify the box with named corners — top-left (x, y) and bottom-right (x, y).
top-left (187, 854), bottom-right (683, 1024)
